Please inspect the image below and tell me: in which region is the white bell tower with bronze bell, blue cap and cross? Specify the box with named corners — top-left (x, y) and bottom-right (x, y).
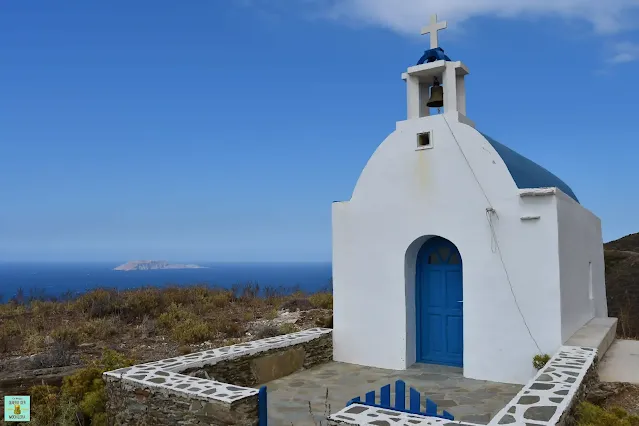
top-left (402, 15), bottom-right (473, 125)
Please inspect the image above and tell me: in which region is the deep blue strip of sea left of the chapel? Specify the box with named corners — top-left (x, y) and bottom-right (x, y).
top-left (0, 262), bottom-right (338, 303)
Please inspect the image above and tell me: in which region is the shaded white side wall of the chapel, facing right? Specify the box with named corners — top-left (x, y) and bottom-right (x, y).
top-left (557, 192), bottom-right (608, 342)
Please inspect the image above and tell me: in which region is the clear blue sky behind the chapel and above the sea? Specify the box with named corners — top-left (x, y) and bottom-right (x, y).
top-left (0, 0), bottom-right (639, 261)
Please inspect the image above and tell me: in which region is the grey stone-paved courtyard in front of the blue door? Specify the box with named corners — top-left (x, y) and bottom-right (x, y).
top-left (266, 362), bottom-right (522, 426)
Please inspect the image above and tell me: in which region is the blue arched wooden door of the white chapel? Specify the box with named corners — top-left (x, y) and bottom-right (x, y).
top-left (415, 237), bottom-right (464, 367)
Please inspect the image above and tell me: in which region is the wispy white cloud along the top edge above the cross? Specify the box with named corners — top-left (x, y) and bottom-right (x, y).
top-left (241, 0), bottom-right (639, 34)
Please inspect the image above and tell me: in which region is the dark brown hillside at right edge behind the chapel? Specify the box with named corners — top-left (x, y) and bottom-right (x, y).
top-left (604, 233), bottom-right (639, 338)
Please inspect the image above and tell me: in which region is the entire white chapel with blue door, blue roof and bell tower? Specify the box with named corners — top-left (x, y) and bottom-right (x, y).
top-left (332, 16), bottom-right (608, 384)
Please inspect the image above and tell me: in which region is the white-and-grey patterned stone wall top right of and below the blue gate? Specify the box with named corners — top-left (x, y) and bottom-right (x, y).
top-left (329, 346), bottom-right (597, 426)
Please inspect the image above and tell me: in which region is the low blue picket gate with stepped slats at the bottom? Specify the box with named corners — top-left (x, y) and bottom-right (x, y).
top-left (346, 380), bottom-right (455, 420)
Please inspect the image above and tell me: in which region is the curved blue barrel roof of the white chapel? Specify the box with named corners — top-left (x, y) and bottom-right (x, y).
top-left (481, 133), bottom-right (579, 202)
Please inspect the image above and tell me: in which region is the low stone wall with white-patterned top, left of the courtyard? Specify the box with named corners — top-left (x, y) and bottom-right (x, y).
top-left (103, 328), bottom-right (333, 426)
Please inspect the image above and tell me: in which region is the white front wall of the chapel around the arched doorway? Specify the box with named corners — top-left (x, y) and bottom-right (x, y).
top-left (333, 113), bottom-right (562, 384)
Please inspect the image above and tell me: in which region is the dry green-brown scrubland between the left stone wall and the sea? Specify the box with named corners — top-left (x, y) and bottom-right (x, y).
top-left (0, 285), bottom-right (333, 426)
